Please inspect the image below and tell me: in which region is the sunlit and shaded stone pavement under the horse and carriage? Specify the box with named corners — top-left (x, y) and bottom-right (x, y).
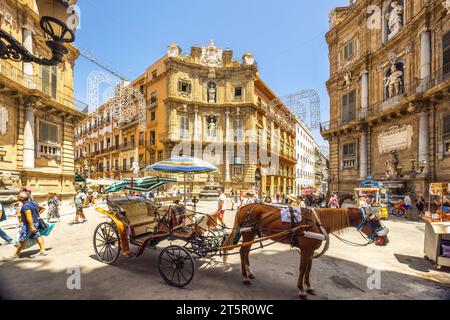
top-left (0, 202), bottom-right (450, 300)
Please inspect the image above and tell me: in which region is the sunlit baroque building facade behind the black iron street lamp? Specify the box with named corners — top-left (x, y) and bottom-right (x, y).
top-left (0, 0), bottom-right (86, 201)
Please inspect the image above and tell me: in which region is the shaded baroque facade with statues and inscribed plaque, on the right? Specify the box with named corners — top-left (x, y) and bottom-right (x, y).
top-left (321, 0), bottom-right (450, 194)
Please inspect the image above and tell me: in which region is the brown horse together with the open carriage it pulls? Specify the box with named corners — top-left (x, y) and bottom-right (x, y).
top-left (93, 158), bottom-right (388, 299)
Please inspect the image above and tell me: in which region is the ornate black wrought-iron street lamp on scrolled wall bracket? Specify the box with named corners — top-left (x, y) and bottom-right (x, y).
top-left (0, 0), bottom-right (75, 66)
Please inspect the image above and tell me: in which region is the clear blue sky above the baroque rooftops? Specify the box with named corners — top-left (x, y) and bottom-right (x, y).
top-left (75, 0), bottom-right (348, 144)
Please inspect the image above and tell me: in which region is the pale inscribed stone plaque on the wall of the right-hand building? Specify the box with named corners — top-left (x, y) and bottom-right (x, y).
top-left (378, 125), bottom-right (414, 154)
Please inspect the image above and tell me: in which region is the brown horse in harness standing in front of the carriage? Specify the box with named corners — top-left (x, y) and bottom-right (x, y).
top-left (223, 204), bottom-right (389, 299)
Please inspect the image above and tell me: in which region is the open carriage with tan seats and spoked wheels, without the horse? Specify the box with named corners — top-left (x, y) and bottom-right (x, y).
top-left (93, 197), bottom-right (226, 288)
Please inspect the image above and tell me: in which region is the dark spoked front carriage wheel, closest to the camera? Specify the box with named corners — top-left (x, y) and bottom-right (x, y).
top-left (158, 246), bottom-right (195, 288)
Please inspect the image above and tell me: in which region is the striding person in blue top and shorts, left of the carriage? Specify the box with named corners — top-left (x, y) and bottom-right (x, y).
top-left (5, 192), bottom-right (48, 260)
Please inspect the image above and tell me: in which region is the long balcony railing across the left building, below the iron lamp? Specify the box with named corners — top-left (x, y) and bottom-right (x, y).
top-left (0, 60), bottom-right (88, 115)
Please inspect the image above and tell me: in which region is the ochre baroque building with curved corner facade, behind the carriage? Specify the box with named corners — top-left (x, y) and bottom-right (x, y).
top-left (75, 42), bottom-right (297, 195)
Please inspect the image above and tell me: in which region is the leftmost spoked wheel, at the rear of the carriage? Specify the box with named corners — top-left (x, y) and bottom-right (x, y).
top-left (94, 222), bottom-right (120, 264)
